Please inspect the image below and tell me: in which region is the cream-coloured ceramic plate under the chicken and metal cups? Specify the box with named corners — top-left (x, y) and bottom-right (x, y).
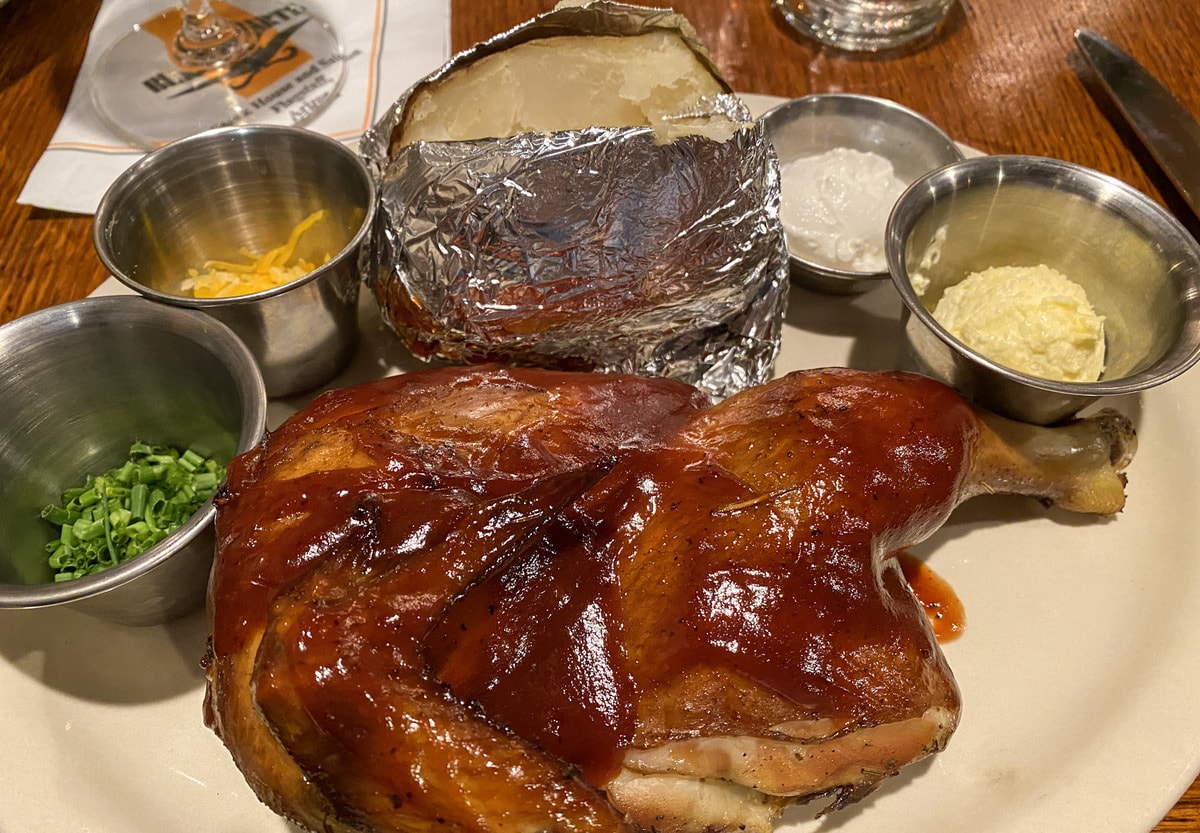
top-left (0, 96), bottom-right (1200, 833)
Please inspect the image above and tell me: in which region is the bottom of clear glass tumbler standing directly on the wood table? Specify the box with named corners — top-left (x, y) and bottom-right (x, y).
top-left (772, 0), bottom-right (955, 52)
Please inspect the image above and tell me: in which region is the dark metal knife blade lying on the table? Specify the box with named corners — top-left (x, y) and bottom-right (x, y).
top-left (1075, 29), bottom-right (1200, 217)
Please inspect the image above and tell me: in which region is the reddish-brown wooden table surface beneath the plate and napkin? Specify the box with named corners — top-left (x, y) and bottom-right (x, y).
top-left (0, 0), bottom-right (1200, 833)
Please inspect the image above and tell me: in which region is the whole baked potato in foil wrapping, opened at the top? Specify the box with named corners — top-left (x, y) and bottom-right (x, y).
top-left (364, 2), bottom-right (787, 396)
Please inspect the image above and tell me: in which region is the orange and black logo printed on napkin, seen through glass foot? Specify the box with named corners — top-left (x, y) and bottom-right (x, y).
top-left (140, 0), bottom-right (331, 118)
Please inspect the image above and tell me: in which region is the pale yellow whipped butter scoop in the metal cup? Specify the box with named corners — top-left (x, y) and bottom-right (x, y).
top-left (934, 265), bottom-right (1104, 382)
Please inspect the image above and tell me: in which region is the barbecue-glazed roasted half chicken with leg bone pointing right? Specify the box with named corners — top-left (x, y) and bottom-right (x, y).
top-left (205, 367), bottom-right (1133, 832)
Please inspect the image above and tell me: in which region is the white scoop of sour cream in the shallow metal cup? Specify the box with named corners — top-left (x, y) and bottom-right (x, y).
top-left (780, 148), bottom-right (905, 272)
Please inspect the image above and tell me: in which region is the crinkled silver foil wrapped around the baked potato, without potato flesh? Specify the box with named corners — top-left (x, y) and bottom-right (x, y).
top-left (362, 2), bottom-right (788, 397)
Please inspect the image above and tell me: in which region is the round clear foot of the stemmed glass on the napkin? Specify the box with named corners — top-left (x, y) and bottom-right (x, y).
top-left (90, 0), bottom-right (346, 149)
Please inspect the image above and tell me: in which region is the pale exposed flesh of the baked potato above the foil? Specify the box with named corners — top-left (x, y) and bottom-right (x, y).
top-left (398, 31), bottom-right (737, 145)
